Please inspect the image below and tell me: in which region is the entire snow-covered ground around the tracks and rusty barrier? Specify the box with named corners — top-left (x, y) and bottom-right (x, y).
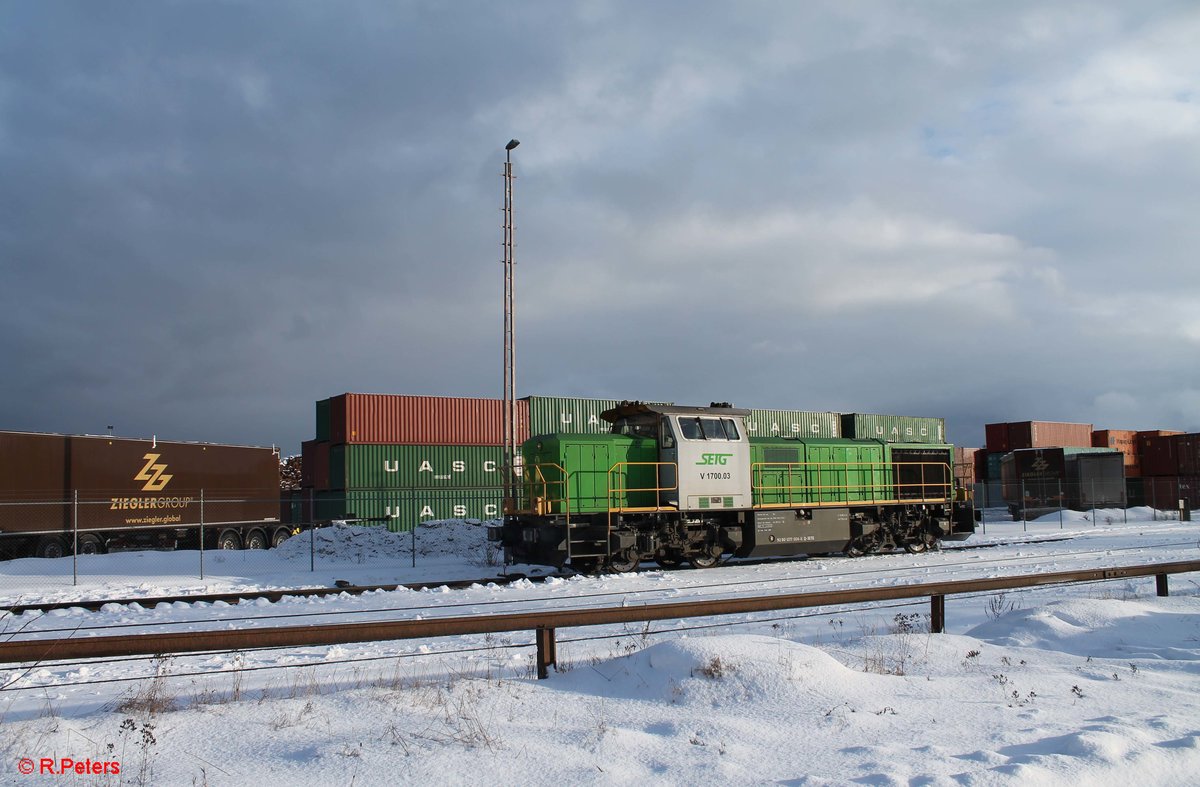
top-left (0, 510), bottom-right (1200, 785)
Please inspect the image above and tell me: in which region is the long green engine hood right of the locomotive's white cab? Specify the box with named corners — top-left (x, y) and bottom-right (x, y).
top-left (750, 438), bottom-right (892, 506)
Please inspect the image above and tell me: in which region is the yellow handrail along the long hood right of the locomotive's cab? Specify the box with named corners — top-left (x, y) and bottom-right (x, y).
top-left (750, 462), bottom-right (954, 509)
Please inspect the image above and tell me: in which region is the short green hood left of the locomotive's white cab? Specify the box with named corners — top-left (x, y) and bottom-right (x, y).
top-left (522, 434), bottom-right (661, 515)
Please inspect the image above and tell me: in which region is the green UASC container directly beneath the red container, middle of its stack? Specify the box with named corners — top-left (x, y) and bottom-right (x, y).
top-left (329, 445), bottom-right (504, 489)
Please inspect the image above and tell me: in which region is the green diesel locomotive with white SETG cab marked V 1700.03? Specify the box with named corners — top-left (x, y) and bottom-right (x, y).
top-left (488, 402), bottom-right (974, 571)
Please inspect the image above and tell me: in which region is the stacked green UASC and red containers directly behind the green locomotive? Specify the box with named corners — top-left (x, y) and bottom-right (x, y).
top-left (293, 394), bottom-right (946, 531)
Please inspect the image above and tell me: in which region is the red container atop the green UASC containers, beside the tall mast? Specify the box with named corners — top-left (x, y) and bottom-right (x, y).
top-left (329, 394), bottom-right (529, 445)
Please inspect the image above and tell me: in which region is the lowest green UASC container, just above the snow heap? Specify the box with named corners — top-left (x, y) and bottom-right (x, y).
top-left (317, 489), bottom-right (502, 533)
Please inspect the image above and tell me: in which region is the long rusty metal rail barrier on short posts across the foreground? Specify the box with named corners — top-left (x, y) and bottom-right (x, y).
top-left (0, 560), bottom-right (1200, 678)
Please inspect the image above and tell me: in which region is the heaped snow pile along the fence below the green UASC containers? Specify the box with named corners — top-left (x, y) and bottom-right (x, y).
top-left (276, 519), bottom-right (499, 565)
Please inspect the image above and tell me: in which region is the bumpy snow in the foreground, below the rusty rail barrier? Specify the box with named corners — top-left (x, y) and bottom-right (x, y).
top-left (7, 599), bottom-right (1200, 787)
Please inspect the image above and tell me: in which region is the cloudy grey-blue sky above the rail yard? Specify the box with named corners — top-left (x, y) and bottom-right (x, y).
top-left (0, 0), bottom-right (1200, 451)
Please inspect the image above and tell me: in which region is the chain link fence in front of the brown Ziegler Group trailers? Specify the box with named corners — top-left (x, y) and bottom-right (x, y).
top-left (0, 487), bottom-right (502, 592)
